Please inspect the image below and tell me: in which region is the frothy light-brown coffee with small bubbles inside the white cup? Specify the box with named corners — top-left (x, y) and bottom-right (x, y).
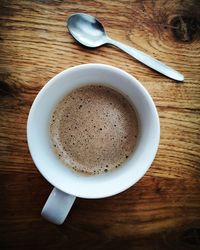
top-left (50, 85), bottom-right (138, 175)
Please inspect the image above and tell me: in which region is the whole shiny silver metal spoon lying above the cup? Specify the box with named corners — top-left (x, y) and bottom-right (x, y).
top-left (67, 13), bottom-right (184, 81)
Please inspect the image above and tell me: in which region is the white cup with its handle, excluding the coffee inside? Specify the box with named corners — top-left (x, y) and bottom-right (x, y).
top-left (27, 64), bottom-right (160, 224)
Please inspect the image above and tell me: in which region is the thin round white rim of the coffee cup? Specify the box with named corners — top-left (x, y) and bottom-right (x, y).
top-left (27, 63), bottom-right (160, 199)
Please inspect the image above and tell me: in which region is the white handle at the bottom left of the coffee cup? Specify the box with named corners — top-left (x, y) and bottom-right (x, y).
top-left (41, 188), bottom-right (76, 225)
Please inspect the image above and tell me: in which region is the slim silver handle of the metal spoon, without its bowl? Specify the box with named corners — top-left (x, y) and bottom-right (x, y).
top-left (107, 38), bottom-right (184, 81)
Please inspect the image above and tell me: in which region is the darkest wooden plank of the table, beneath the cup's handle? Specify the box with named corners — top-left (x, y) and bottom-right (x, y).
top-left (0, 173), bottom-right (200, 249)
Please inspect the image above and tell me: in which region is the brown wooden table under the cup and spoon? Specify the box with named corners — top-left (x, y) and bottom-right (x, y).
top-left (0, 0), bottom-right (200, 250)
